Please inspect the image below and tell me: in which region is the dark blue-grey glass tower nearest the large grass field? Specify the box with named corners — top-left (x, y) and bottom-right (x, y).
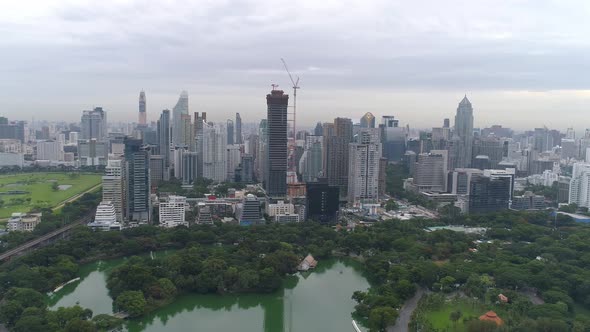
top-left (125, 138), bottom-right (152, 223)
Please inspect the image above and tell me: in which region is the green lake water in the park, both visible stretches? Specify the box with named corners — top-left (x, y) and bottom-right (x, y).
top-left (50, 255), bottom-right (369, 332)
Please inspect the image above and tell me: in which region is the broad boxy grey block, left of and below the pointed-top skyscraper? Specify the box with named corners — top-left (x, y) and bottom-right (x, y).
top-left (414, 150), bottom-right (447, 192)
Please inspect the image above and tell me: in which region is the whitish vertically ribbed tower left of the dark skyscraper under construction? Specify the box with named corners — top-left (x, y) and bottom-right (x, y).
top-left (203, 123), bottom-right (227, 182)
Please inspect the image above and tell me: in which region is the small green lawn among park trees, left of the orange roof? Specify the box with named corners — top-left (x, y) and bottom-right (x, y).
top-left (425, 300), bottom-right (487, 331)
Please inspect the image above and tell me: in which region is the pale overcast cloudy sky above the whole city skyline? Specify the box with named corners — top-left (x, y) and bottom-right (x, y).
top-left (0, 0), bottom-right (590, 129)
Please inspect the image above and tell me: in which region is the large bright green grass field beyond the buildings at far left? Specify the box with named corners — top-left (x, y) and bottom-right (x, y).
top-left (0, 173), bottom-right (101, 219)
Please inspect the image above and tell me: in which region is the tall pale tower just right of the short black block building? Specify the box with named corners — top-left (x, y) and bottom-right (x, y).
top-left (348, 128), bottom-right (381, 206)
